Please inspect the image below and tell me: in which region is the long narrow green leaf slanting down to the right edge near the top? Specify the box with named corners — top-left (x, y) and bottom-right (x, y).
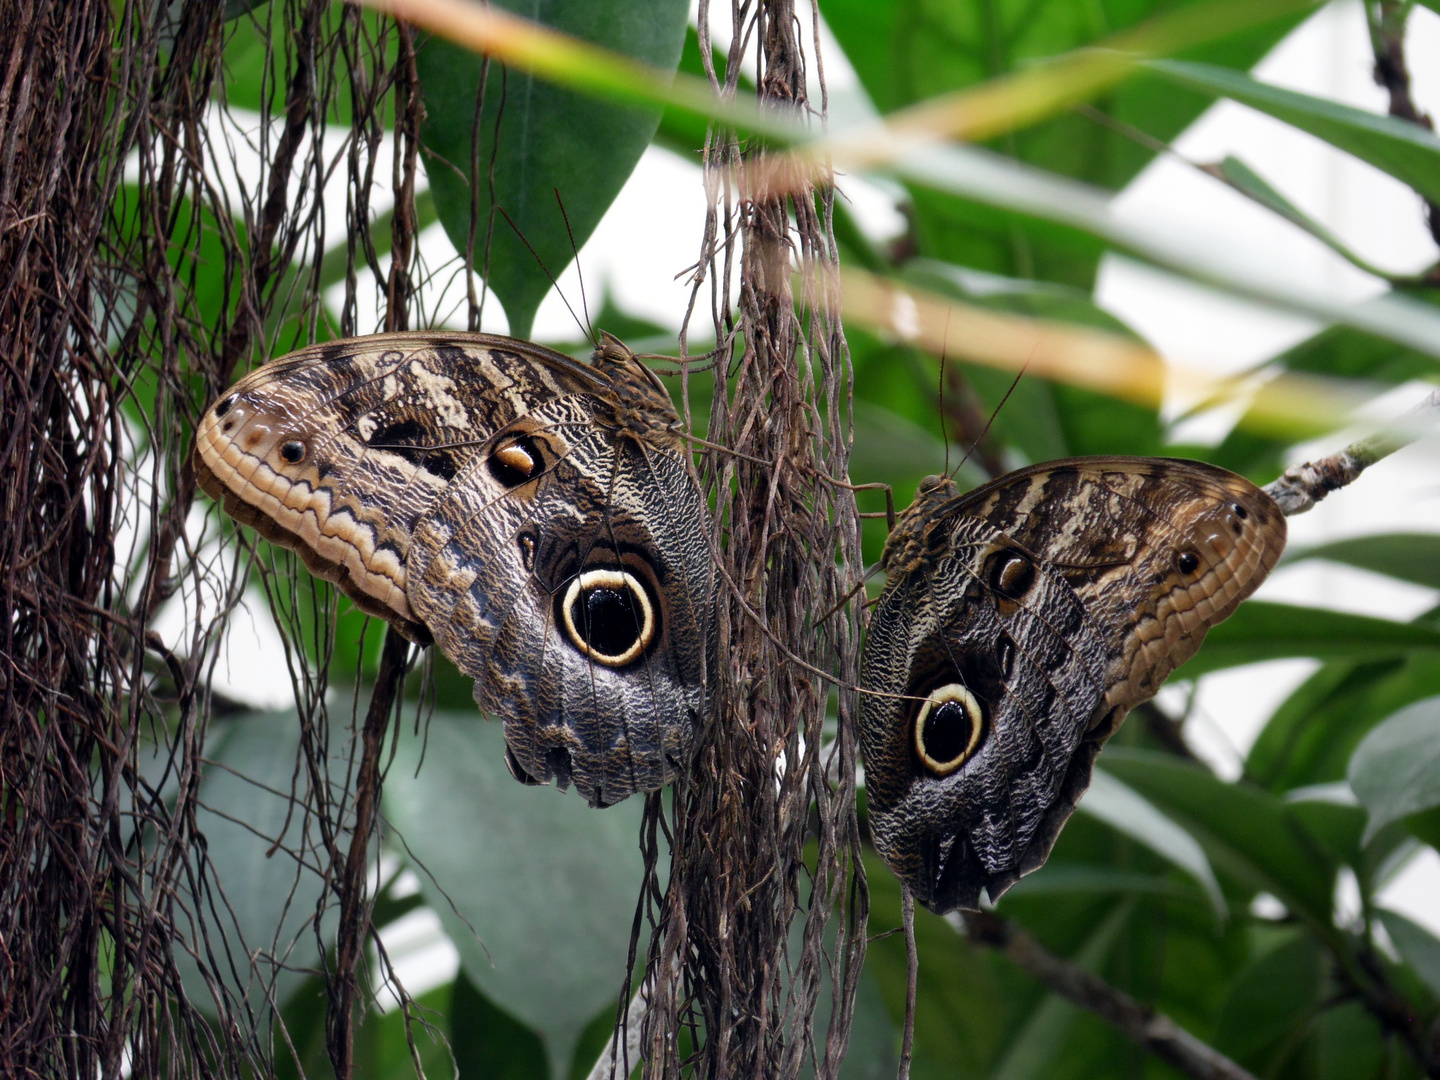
top-left (1145, 60), bottom-right (1440, 202)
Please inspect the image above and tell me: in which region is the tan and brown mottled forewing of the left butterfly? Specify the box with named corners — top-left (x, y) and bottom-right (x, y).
top-left (196, 334), bottom-right (598, 639)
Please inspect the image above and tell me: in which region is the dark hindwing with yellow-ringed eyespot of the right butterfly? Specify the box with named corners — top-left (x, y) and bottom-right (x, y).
top-left (861, 517), bottom-right (1104, 912)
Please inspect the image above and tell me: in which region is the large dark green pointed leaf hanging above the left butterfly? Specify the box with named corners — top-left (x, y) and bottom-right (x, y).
top-left (418, 0), bottom-right (688, 337)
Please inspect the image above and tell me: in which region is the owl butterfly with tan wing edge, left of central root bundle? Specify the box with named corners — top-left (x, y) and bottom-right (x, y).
top-left (193, 333), bottom-right (714, 806)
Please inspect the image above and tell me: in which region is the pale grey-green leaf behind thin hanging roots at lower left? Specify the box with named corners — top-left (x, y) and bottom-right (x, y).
top-left (176, 713), bottom-right (336, 1012)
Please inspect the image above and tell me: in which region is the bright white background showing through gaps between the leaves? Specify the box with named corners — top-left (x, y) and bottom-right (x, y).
top-left (208, 0), bottom-right (1440, 992)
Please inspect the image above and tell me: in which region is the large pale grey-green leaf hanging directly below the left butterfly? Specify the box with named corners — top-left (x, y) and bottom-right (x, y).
top-left (384, 713), bottom-right (644, 1077)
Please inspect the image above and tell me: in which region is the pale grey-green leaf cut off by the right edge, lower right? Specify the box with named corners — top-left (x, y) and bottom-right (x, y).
top-left (1348, 697), bottom-right (1440, 840)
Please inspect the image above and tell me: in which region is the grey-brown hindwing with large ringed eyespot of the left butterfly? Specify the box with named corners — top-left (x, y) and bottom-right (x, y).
top-left (410, 400), bottom-right (714, 805)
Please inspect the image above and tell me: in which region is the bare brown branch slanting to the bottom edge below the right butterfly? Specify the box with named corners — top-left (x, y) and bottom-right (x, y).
top-left (960, 912), bottom-right (1256, 1080)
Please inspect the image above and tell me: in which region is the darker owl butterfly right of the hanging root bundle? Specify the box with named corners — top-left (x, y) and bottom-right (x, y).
top-left (860, 458), bottom-right (1286, 913)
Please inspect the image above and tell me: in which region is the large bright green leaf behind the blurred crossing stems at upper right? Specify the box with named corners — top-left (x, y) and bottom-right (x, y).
top-left (821, 0), bottom-right (1299, 289)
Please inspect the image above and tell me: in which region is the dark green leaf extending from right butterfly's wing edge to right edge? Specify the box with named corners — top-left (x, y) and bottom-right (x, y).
top-left (1175, 600), bottom-right (1440, 678)
